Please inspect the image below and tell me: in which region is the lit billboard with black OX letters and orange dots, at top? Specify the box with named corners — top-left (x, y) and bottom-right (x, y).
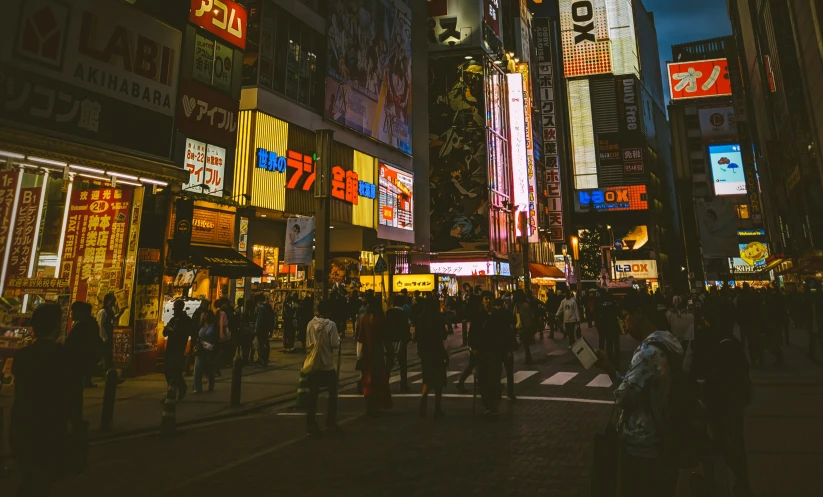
top-left (560, 0), bottom-right (612, 78)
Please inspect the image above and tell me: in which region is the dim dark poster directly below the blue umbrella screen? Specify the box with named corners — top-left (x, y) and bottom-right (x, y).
top-left (695, 198), bottom-right (740, 258)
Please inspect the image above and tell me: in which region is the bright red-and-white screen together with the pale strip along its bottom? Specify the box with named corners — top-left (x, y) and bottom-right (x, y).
top-left (377, 162), bottom-right (414, 243)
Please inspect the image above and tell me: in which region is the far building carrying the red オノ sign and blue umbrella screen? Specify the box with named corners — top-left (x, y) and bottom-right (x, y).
top-left (668, 37), bottom-right (770, 288)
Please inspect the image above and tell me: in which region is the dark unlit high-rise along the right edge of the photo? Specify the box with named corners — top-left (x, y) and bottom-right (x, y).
top-left (728, 0), bottom-right (823, 283)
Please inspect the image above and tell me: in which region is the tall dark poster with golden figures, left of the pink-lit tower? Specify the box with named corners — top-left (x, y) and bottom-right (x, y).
top-left (429, 56), bottom-right (489, 252)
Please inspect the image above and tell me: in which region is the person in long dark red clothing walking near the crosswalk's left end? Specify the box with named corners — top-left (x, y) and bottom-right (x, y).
top-left (357, 297), bottom-right (392, 416)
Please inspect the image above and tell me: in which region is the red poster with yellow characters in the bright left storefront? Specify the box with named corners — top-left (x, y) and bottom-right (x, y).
top-left (60, 188), bottom-right (132, 310)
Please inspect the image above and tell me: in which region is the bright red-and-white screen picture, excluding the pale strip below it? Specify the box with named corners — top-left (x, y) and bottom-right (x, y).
top-left (378, 162), bottom-right (414, 231)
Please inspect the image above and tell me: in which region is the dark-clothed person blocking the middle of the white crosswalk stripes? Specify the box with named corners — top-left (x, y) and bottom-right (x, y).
top-left (469, 291), bottom-right (511, 420)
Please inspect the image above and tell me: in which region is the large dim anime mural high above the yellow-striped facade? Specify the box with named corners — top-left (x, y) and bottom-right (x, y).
top-left (325, 0), bottom-right (412, 154)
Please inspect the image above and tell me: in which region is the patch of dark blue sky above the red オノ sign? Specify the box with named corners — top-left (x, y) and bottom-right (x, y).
top-left (643, 0), bottom-right (732, 105)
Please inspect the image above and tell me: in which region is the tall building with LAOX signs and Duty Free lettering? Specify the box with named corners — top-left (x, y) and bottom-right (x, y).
top-left (559, 0), bottom-right (684, 288)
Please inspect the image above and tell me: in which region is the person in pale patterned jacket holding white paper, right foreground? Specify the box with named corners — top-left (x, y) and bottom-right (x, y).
top-left (597, 292), bottom-right (689, 497)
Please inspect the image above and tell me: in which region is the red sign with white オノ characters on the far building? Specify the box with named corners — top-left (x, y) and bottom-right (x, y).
top-left (668, 59), bottom-right (732, 100)
